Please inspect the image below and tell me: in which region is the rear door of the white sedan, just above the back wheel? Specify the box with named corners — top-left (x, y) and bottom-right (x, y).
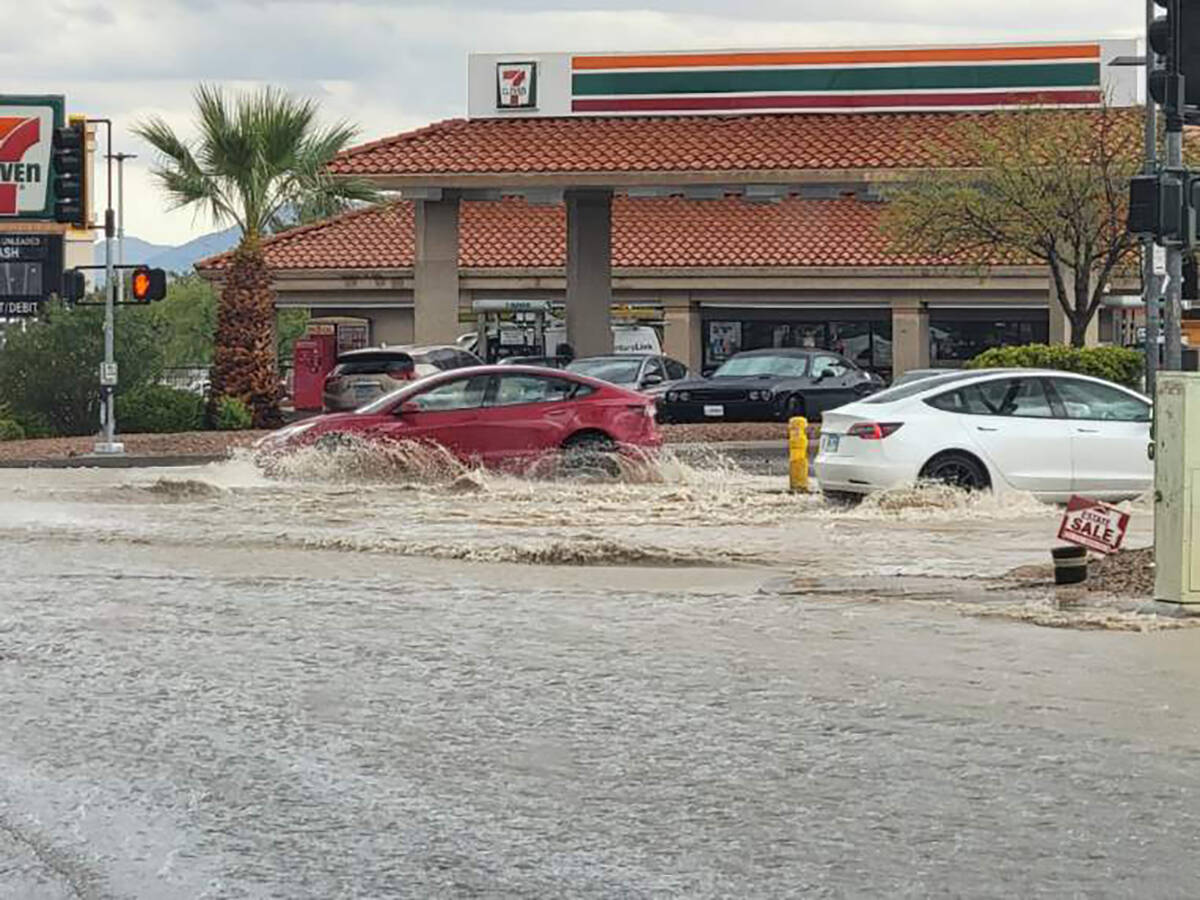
top-left (958, 376), bottom-right (1073, 498)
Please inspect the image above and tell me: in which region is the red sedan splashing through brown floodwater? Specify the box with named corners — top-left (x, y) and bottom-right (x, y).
top-left (263, 366), bottom-right (662, 466)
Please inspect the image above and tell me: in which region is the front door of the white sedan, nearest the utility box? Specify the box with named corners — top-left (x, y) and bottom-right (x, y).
top-left (1050, 377), bottom-right (1154, 499)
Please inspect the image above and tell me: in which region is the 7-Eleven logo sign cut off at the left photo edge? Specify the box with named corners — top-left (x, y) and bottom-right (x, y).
top-left (0, 96), bottom-right (62, 218)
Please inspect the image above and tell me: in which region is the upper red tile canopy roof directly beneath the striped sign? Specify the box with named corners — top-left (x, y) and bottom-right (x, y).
top-left (330, 110), bottom-right (1136, 175)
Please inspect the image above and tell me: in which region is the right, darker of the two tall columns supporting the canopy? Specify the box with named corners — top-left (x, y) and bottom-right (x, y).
top-left (566, 191), bottom-right (612, 356)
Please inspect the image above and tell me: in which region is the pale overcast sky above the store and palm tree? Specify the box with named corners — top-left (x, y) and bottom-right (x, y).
top-left (0, 0), bottom-right (1144, 244)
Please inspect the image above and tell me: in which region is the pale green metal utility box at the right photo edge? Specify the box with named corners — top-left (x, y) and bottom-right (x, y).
top-left (1154, 372), bottom-right (1200, 604)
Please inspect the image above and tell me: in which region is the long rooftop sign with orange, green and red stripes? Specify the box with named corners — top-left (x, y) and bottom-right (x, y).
top-left (467, 40), bottom-right (1140, 118)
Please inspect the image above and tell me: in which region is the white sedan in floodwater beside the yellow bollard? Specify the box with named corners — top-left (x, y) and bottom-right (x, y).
top-left (815, 370), bottom-right (1153, 500)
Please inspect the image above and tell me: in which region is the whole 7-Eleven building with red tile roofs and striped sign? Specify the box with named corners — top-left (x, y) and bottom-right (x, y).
top-left (198, 41), bottom-right (1138, 372)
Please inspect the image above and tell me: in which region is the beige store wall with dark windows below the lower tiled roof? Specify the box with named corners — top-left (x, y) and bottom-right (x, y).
top-left (258, 269), bottom-right (1118, 374)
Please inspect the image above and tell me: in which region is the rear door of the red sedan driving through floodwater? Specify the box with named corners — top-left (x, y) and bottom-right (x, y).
top-left (478, 372), bottom-right (590, 461)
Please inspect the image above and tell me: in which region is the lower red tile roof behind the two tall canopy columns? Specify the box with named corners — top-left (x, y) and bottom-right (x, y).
top-left (197, 196), bottom-right (947, 269)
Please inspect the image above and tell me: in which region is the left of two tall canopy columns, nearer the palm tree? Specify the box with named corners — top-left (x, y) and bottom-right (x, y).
top-left (413, 191), bottom-right (460, 344)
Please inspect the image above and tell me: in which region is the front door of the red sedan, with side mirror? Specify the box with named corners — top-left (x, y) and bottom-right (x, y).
top-left (374, 376), bottom-right (491, 460)
